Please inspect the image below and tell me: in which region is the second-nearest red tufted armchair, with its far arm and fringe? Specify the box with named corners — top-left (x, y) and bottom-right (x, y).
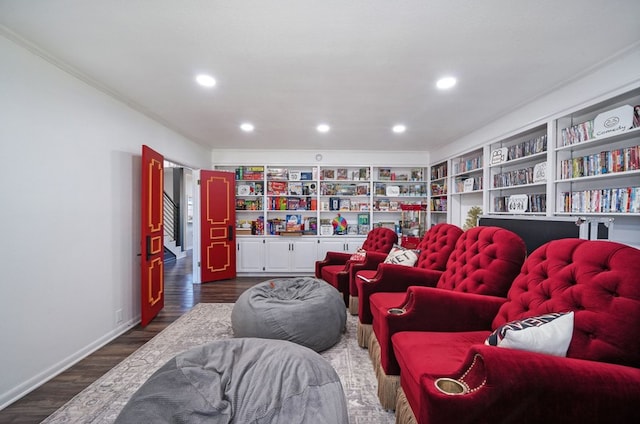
top-left (356, 227), bottom-right (526, 350)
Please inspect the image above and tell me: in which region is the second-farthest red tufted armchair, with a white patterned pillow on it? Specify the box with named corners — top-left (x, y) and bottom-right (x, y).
top-left (349, 223), bottom-right (463, 347)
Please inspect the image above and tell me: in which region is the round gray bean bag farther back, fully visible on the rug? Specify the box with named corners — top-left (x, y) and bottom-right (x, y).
top-left (231, 277), bottom-right (347, 352)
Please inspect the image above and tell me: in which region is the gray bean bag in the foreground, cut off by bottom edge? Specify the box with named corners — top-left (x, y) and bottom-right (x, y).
top-left (115, 338), bottom-right (348, 424)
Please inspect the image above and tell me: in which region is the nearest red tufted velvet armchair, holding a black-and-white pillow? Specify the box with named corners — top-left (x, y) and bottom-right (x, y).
top-left (387, 239), bottom-right (640, 424)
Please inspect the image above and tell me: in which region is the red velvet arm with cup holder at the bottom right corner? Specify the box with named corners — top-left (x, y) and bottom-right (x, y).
top-left (414, 345), bottom-right (640, 424)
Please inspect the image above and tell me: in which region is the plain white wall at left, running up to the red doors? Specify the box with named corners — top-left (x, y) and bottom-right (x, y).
top-left (0, 36), bottom-right (211, 409)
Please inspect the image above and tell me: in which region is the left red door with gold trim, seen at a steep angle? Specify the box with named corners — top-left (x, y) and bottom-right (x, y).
top-left (140, 146), bottom-right (164, 326)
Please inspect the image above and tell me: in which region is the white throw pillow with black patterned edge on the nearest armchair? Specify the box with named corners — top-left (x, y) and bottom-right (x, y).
top-left (485, 312), bottom-right (573, 356)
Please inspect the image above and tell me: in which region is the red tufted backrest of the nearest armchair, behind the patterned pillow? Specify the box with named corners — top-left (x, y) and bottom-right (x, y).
top-left (493, 239), bottom-right (640, 367)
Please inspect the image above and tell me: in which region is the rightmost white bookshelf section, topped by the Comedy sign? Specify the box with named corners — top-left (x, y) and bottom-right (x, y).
top-left (554, 88), bottom-right (640, 219)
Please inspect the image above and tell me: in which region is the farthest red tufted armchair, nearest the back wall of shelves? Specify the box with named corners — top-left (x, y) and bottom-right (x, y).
top-left (315, 227), bottom-right (398, 306)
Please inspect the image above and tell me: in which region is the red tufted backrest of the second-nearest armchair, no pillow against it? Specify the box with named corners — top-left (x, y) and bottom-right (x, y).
top-left (436, 226), bottom-right (527, 297)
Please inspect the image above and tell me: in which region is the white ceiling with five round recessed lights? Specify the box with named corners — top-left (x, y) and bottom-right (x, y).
top-left (0, 0), bottom-right (640, 151)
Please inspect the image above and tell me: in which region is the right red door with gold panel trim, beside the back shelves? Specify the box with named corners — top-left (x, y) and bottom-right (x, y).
top-left (200, 171), bottom-right (236, 283)
